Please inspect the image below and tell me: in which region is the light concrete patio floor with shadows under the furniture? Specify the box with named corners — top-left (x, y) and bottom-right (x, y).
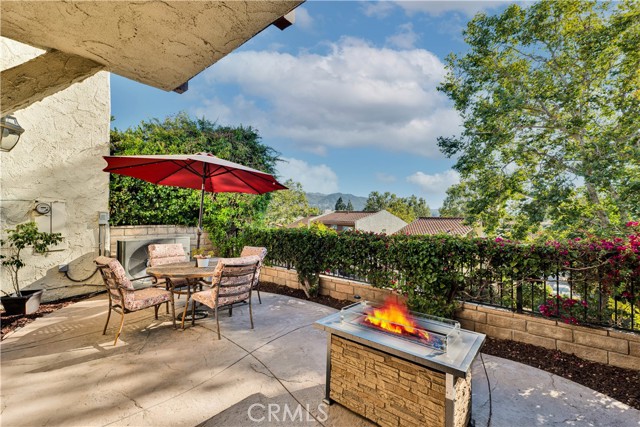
top-left (0, 293), bottom-right (640, 427)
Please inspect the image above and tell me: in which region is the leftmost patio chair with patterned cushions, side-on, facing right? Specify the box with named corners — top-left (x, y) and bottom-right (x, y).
top-left (95, 256), bottom-right (176, 346)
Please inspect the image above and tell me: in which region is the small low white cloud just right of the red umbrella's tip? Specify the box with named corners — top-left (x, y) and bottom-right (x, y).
top-left (277, 157), bottom-right (338, 194)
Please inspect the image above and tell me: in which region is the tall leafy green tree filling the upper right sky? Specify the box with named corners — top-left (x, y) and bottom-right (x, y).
top-left (438, 0), bottom-right (640, 237)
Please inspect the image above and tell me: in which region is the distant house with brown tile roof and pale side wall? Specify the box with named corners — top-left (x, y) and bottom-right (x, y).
top-left (288, 210), bottom-right (407, 234)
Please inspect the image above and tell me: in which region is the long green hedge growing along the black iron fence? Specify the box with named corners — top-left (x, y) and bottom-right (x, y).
top-left (241, 222), bottom-right (640, 329)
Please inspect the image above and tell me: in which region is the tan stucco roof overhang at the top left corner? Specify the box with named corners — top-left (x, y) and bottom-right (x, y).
top-left (0, 0), bottom-right (304, 115)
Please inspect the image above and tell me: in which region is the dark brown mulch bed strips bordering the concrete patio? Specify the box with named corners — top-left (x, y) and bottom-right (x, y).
top-left (0, 282), bottom-right (640, 409)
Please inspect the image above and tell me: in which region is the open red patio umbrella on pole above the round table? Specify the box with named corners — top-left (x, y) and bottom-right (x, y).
top-left (103, 153), bottom-right (287, 248)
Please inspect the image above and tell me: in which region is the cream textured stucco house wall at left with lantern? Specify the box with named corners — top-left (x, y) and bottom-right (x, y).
top-left (0, 38), bottom-right (111, 300)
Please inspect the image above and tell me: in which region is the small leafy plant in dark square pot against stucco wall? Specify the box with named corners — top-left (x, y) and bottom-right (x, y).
top-left (0, 221), bottom-right (63, 315)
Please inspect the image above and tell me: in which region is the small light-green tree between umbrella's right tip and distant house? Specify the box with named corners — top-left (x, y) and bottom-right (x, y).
top-left (265, 179), bottom-right (320, 227)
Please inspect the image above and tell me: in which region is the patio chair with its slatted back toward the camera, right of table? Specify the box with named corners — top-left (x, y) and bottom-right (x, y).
top-left (191, 255), bottom-right (260, 339)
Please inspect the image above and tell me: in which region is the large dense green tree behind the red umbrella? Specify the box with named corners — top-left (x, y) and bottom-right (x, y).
top-left (109, 113), bottom-right (278, 254)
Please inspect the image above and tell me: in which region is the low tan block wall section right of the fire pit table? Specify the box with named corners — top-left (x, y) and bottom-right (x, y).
top-left (456, 303), bottom-right (640, 370)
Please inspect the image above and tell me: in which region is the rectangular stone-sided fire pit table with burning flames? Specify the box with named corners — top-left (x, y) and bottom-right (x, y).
top-left (314, 301), bottom-right (485, 427)
